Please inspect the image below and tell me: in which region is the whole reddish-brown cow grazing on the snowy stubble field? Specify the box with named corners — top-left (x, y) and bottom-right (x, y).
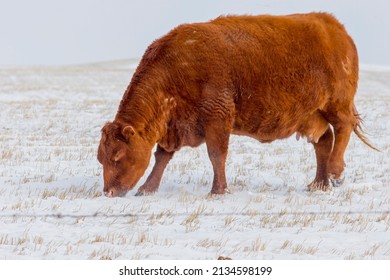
top-left (98, 13), bottom-right (372, 197)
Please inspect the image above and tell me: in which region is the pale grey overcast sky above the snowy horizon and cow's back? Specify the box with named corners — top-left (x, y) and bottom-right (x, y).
top-left (0, 0), bottom-right (390, 66)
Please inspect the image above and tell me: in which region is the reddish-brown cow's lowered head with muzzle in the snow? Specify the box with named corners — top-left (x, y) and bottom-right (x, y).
top-left (97, 123), bottom-right (152, 197)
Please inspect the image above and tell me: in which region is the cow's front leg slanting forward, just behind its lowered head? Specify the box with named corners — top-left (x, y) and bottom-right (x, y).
top-left (136, 145), bottom-right (175, 196)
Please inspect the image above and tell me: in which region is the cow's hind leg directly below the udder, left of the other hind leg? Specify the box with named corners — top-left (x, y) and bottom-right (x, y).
top-left (308, 125), bottom-right (334, 191)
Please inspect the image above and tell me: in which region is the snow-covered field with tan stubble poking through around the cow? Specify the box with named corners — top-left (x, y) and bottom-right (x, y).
top-left (0, 61), bottom-right (390, 259)
